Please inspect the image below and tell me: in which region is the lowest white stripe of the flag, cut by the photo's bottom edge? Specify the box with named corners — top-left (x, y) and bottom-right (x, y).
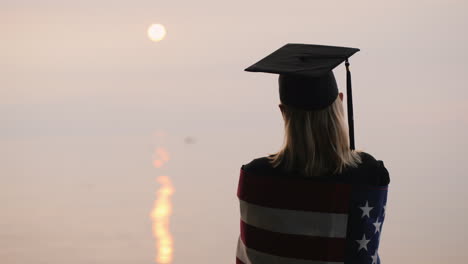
top-left (236, 236), bottom-right (344, 264)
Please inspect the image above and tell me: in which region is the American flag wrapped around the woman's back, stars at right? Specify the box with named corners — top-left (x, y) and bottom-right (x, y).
top-left (236, 169), bottom-right (388, 264)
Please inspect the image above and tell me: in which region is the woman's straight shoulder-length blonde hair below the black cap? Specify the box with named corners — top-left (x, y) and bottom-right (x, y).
top-left (269, 93), bottom-right (362, 177)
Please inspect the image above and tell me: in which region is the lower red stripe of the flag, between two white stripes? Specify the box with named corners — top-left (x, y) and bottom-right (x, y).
top-left (241, 220), bottom-right (346, 261)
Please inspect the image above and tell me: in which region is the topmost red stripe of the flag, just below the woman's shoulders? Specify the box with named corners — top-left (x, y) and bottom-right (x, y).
top-left (237, 169), bottom-right (351, 213)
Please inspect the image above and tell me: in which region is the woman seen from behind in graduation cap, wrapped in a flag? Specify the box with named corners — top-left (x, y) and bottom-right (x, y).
top-left (236, 44), bottom-right (390, 264)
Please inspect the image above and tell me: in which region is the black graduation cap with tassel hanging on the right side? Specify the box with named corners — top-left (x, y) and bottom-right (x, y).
top-left (244, 43), bottom-right (359, 149)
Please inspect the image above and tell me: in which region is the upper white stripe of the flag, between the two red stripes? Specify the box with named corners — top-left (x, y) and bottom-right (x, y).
top-left (239, 199), bottom-right (348, 238)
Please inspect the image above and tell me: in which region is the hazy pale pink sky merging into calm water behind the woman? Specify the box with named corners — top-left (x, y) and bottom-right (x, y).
top-left (0, 0), bottom-right (468, 264)
